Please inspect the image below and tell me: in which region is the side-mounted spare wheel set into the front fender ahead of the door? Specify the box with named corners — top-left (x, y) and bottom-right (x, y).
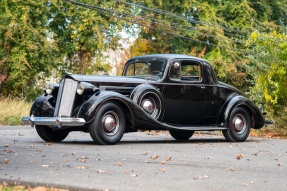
top-left (131, 84), bottom-right (164, 120)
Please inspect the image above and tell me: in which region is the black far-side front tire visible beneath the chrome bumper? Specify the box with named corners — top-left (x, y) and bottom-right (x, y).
top-left (36, 125), bottom-right (69, 142)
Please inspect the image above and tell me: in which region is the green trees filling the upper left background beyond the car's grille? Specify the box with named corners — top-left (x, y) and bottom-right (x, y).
top-left (0, 0), bottom-right (124, 99)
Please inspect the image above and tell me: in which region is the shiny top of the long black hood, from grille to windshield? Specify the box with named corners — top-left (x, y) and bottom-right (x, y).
top-left (65, 74), bottom-right (156, 84)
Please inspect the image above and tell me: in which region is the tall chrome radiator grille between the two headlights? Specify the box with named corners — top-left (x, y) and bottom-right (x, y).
top-left (54, 79), bottom-right (78, 117)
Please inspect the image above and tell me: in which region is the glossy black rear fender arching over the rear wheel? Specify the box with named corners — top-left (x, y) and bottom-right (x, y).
top-left (217, 94), bottom-right (264, 129)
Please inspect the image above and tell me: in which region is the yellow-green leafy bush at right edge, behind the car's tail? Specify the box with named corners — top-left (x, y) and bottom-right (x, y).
top-left (246, 31), bottom-right (287, 115)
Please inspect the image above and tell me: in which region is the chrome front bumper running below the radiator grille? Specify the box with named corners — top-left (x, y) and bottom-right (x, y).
top-left (22, 115), bottom-right (86, 128)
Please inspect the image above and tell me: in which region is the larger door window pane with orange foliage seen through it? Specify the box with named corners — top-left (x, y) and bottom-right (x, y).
top-left (180, 61), bottom-right (201, 81)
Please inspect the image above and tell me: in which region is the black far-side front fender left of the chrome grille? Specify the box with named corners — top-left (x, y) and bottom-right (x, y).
top-left (30, 94), bottom-right (55, 117)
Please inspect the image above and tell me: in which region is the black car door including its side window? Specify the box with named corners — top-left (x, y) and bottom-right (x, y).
top-left (163, 60), bottom-right (205, 125)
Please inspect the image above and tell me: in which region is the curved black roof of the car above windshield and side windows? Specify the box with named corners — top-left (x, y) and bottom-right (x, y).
top-left (128, 54), bottom-right (208, 63)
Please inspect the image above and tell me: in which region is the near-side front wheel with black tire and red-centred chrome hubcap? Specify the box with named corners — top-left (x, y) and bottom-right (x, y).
top-left (89, 102), bottom-right (126, 145)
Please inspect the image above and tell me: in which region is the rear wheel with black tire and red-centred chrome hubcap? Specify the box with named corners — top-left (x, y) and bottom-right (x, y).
top-left (222, 107), bottom-right (252, 142)
